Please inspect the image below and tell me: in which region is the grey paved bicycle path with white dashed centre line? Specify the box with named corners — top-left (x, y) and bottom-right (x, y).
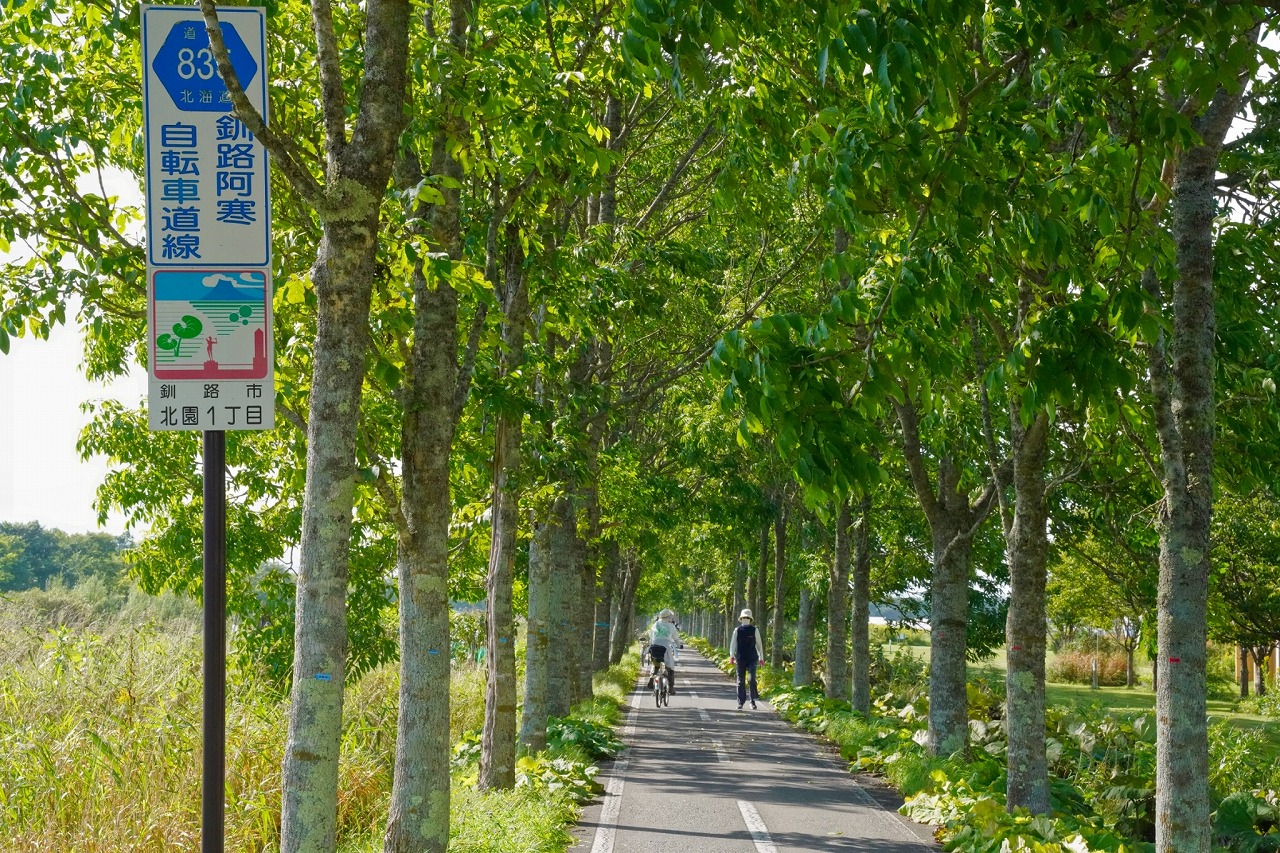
top-left (571, 648), bottom-right (937, 853)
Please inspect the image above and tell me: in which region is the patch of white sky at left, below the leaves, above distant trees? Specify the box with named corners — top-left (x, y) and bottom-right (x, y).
top-left (0, 311), bottom-right (147, 534)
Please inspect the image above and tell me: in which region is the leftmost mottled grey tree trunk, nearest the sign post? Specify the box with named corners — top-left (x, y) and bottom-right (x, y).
top-left (267, 0), bottom-right (411, 853)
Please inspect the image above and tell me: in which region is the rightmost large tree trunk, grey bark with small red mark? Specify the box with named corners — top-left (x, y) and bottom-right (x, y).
top-left (1148, 74), bottom-right (1257, 853)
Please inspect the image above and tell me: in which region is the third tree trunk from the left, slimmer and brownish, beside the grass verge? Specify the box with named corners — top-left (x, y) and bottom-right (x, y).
top-left (479, 225), bottom-right (529, 789)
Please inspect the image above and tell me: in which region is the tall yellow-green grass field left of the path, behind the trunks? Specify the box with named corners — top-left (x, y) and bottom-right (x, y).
top-left (0, 589), bottom-right (609, 853)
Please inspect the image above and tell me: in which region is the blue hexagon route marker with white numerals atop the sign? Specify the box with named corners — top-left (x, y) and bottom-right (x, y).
top-left (151, 18), bottom-right (257, 113)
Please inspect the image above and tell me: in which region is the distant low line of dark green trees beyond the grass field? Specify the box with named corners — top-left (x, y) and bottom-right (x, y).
top-left (0, 521), bottom-right (133, 592)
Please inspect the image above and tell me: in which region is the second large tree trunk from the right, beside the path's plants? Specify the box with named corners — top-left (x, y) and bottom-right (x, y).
top-left (1005, 411), bottom-right (1050, 815)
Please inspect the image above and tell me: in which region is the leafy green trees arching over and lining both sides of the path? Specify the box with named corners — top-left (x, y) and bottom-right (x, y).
top-left (0, 0), bottom-right (1280, 852)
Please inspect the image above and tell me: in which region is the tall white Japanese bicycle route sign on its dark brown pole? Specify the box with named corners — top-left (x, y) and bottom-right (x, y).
top-left (142, 4), bottom-right (275, 853)
